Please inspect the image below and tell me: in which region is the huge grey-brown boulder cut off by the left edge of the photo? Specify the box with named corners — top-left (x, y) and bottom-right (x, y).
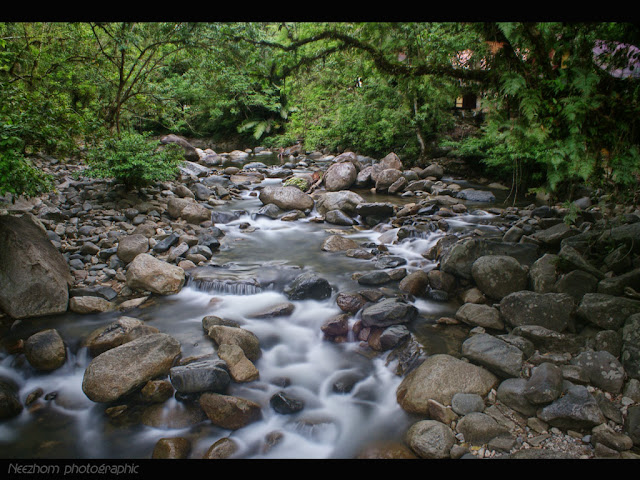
top-left (0, 215), bottom-right (73, 319)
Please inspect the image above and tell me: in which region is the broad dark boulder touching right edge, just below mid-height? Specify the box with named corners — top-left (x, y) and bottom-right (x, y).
top-left (576, 293), bottom-right (640, 330)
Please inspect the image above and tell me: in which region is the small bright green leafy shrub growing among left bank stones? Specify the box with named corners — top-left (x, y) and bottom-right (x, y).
top-left (83, 132), bottom-right (184, 189)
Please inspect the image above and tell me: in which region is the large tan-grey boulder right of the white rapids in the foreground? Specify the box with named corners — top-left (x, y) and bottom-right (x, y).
top-left (396, 354), bottom-right (498, 415)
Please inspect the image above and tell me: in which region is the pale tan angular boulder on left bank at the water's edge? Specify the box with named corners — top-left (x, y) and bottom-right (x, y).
top-left (126, 253), bottom-right (185, 295)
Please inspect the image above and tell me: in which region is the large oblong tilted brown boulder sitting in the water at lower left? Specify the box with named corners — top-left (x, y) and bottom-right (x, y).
top-left (82, 333), bottom-right (180, 403)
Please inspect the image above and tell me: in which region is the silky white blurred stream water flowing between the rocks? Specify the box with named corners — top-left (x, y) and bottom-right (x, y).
top-left (0, 156), bottom-right (510, 459)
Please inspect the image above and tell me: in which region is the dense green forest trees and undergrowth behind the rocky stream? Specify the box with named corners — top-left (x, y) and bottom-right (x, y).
top-left (0, 22), bottom-right (640, 200)
